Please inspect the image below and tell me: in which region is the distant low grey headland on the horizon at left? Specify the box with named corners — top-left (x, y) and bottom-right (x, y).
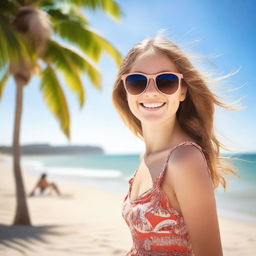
top-left (0, 143), bottom-right (104, 155)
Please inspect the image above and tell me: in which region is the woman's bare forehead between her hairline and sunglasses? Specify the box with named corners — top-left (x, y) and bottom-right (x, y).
top-left (130, 50), bottom-right (177, 74)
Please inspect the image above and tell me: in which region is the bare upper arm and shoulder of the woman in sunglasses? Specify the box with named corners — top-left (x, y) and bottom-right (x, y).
top-left (167, 146), bottom-right (223, 256)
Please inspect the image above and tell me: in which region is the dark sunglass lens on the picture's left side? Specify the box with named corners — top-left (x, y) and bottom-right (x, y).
top-left (125, 74), bottom-right (147, 95)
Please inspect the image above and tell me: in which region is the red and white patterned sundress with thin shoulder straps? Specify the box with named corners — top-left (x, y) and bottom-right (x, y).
top-left (122, 141), bottom-right (210, 256)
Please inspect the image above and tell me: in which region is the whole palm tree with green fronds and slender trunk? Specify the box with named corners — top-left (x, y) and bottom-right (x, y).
top-left (0, 0), bottom-right (122, 225)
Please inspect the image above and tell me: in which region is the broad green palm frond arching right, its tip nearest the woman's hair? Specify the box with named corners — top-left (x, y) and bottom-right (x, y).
top-left (53, 21), bottom-right (122, 65)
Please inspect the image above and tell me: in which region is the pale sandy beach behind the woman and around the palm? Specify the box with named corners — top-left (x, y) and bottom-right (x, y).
top-left (0, 155), bottom-right (256, 256)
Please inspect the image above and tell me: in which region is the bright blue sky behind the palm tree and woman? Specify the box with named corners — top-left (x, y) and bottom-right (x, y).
top-left (0, 0), bottom-right (256, 154)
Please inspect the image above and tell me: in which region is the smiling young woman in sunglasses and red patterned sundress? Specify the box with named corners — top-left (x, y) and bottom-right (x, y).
top-left (112, 37), bottom-right (238, 256)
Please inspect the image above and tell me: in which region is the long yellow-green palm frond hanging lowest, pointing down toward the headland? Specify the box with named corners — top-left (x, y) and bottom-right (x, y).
top-left (40, 65), bottom-right (70, 139)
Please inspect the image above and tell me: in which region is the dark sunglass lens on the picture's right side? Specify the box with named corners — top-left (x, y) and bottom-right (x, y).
top-left (156, 74), bottom-right (179, 94)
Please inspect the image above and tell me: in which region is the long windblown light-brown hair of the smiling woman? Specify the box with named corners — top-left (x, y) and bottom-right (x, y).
top-left (112, 36), bottom-right (240, 192)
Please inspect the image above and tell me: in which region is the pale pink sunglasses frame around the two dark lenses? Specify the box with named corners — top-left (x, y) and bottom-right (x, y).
top-left (121, 71), bottom-right (183, 96)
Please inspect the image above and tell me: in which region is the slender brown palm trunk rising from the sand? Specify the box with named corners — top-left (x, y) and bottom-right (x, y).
top-left (12, 76), bottom-right (31, 225)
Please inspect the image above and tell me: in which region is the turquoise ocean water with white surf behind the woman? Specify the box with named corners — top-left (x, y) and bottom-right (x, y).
top-left (18, 153), bottom-right (256, 222)
